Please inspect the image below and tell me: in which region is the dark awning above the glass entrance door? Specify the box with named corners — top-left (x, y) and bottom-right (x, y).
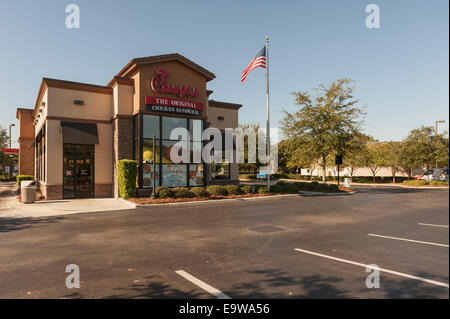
top-left (61, 122), bottom-right (98, 145)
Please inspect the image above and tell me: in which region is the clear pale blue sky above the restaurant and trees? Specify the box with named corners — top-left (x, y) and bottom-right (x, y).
top-left (0, 0), bottom-right (449, 148)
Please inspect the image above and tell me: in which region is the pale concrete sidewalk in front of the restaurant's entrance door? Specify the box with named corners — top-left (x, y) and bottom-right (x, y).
top-left (0, 182), bottom-right (133, 218)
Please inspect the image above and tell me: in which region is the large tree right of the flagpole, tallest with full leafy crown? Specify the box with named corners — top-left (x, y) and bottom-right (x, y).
top-left (281, 79), bottom-right (364, 183)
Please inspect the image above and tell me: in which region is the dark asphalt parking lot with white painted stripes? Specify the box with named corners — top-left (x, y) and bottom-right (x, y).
top-left (0, 186), bottom-right (449, 299)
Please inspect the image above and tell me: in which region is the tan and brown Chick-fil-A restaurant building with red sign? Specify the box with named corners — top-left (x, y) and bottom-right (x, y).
top-left (16, 54), bottom-right (242, 199)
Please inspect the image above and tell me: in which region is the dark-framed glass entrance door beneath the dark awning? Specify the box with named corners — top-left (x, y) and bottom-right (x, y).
top-left (63, 144), bottom-right (94, 198)
